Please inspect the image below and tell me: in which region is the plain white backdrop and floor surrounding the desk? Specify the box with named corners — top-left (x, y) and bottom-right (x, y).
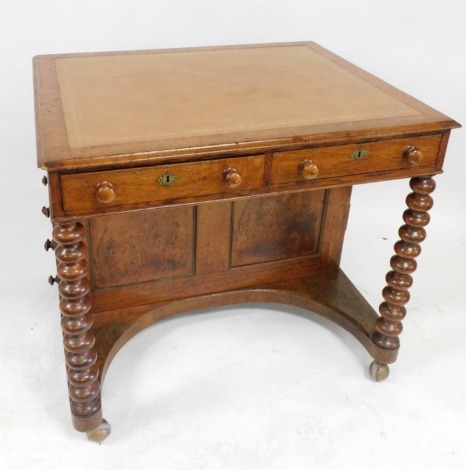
top-left (0, 0), bottom-right (466, 470)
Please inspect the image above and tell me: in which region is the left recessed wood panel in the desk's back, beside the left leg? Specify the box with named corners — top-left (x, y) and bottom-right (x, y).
top-left (89, 206), bottom-right (196, 290)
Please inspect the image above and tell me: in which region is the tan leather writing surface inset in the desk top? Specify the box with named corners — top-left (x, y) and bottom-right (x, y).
top-left (55, 44), bottom-right (420, 148)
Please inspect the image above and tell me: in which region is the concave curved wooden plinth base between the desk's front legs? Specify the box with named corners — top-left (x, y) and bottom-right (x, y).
top-left (93, 270), bottom-right (398, 383)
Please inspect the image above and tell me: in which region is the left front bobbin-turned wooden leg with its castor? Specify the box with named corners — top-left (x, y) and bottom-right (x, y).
top-left (53, 222), bottom-right (110, 442)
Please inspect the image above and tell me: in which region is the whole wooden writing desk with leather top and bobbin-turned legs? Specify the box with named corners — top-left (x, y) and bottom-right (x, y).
top-left (34, 43), bottom-right (459, 441)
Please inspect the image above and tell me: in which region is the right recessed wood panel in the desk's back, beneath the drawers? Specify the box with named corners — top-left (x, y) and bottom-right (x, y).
top-left (231, 190), bottom-right (325, 267)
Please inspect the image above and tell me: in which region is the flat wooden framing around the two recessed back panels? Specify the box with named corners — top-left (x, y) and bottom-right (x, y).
top-left (92, 187), bottom-right (351, 312)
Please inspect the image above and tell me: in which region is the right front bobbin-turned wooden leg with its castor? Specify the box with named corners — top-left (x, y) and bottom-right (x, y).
top-left (370, 177), bottom-right (435, 381)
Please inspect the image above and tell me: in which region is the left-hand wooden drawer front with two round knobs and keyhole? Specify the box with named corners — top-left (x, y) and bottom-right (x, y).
top-left (61, 155), bottom-right (264, 213)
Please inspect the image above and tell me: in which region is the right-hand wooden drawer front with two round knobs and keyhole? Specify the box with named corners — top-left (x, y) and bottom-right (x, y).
top-left (271, 135), bottom-right (441, 185)
